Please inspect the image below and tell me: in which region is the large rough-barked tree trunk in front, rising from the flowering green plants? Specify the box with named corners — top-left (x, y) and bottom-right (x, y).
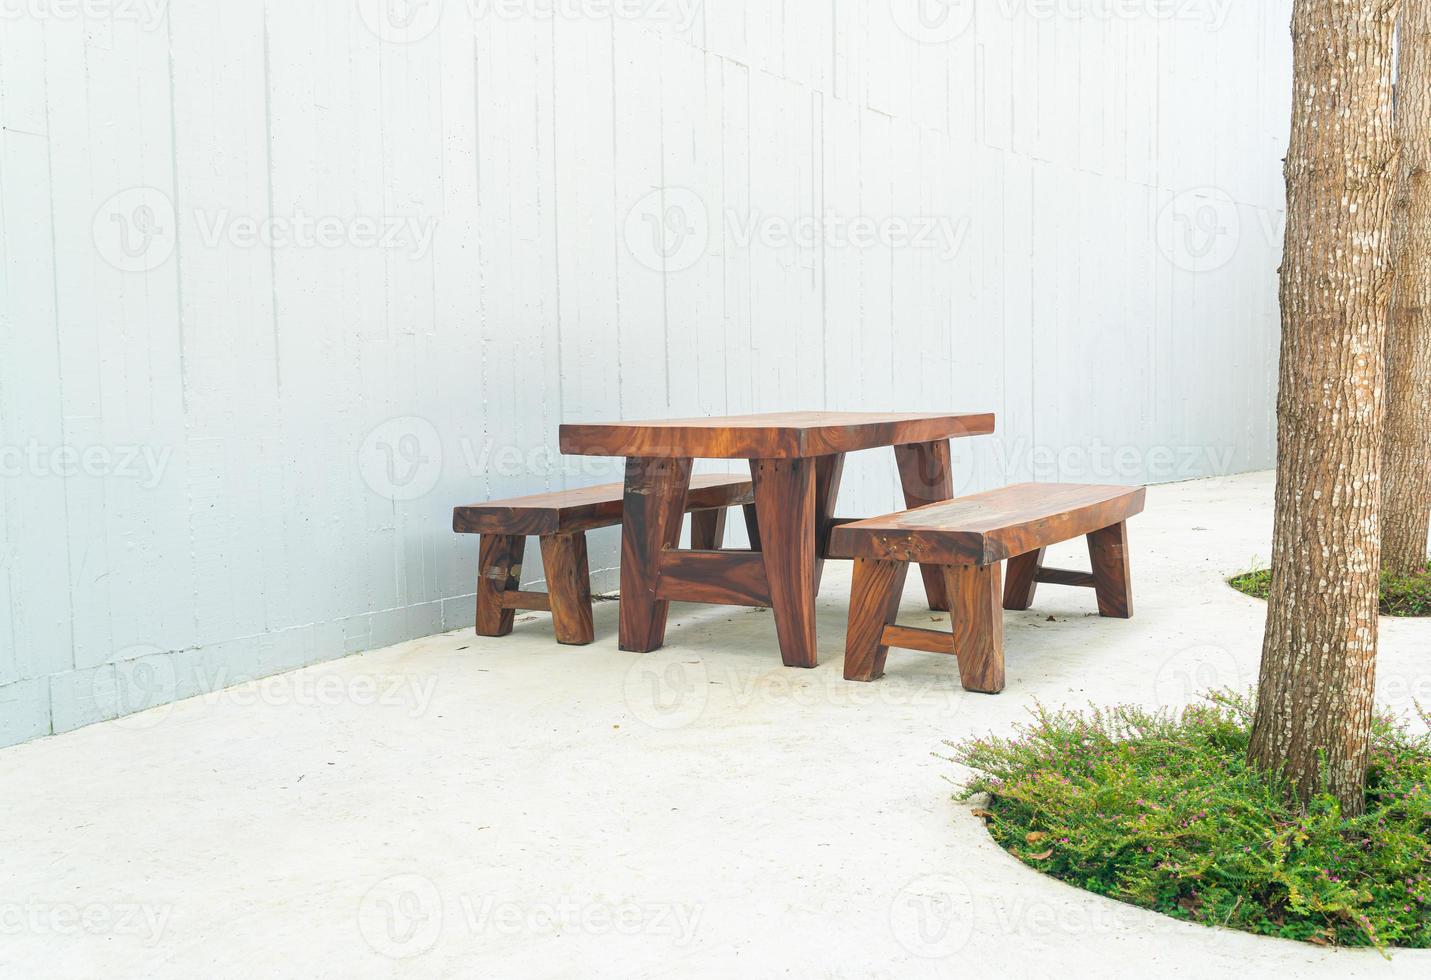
top-left (1249, 0), bottom-right (1397, 815)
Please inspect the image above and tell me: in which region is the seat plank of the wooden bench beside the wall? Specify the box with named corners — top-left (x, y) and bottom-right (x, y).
top-left (452, 474), bottom-right (756, 535)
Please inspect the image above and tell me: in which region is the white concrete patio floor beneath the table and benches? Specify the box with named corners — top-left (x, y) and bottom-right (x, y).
top-left (0, 474), bottom-right (1431, 980)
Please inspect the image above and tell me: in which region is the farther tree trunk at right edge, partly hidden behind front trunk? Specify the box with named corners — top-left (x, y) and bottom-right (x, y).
top-left (1381, 0), bottom-right (1431, 575)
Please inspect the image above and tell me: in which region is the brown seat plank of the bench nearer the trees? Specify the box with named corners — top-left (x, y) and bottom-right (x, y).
top-left (830, 484), bottom-right (1146, 565)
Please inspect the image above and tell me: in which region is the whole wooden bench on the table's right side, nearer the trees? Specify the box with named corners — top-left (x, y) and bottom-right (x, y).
top-left (830, 484), bottom-right (1145, 694)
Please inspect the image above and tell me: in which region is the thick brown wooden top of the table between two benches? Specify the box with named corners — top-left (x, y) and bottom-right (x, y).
top-left (561, 412), bottom-right (995, 459)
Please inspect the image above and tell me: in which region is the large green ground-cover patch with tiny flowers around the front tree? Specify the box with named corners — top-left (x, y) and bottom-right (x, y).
top-left (947, 692), bottom-right (1431, 949)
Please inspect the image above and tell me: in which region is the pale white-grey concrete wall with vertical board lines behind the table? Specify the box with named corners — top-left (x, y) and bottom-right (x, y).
top-left (0, 0), bottom-right (1289, 744)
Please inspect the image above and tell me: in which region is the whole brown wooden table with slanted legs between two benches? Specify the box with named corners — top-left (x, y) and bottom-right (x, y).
top-left (561, 412), bottom-right (995, 667)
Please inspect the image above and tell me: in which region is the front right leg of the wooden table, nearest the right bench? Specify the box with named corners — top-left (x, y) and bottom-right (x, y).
top-left (750, 459), bottom-right (820, 667)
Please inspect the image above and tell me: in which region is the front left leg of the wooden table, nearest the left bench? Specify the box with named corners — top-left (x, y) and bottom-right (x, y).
top-left (620, 456), bottom-right (691, 654)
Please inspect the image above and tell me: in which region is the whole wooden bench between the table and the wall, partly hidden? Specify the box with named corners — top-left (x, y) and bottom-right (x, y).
top-left (452, 475), bottom-right (760, 644)
